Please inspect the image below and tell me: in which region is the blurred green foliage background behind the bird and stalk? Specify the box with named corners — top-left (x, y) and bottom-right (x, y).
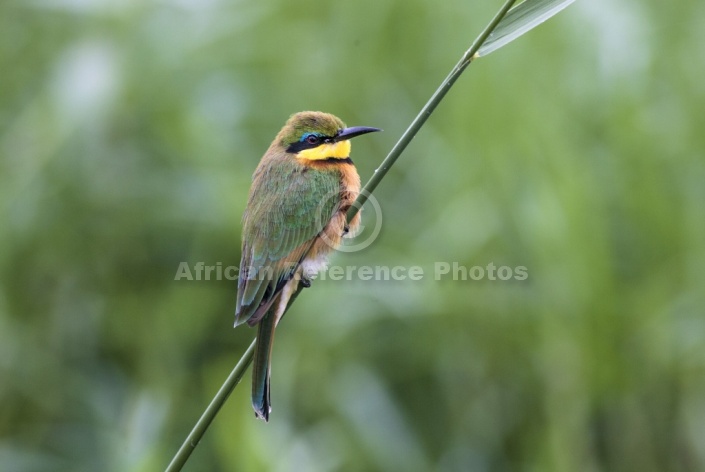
top-left (0, 0), bottom-right (705, 472)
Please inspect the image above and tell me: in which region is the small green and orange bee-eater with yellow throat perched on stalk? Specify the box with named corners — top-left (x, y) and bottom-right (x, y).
top-left (235, 111), bottom-right (382, 422)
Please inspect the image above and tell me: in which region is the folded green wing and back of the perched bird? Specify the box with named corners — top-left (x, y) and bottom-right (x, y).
top-left (235, 157), bottom-right (340, 326)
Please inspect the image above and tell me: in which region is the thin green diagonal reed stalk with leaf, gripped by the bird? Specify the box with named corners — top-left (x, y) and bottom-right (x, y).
top-left (166, 0), bottom-right (575, 472)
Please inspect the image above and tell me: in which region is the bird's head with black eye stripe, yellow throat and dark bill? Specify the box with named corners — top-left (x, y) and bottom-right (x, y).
top-left (275, 111), bottom-right (382, 161)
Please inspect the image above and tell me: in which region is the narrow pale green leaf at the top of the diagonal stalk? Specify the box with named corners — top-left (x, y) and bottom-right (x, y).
top-left (477, 0), bottom-right (575, 56)
